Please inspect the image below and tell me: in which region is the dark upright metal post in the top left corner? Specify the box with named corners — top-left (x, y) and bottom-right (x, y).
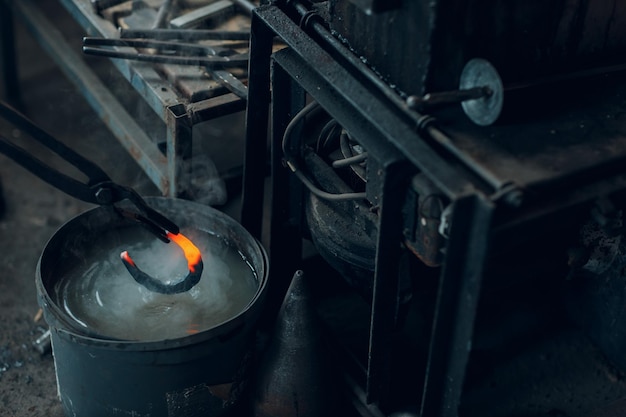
top-left (0, 0), bottom-right (20, 105)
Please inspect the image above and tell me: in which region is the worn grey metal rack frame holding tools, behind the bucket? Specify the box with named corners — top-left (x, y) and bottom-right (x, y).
top-left (0, 0), bottom-right (246, 197)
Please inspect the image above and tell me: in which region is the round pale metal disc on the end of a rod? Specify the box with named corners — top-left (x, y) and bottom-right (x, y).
top-left (459, 58), bottom-right (504, 126)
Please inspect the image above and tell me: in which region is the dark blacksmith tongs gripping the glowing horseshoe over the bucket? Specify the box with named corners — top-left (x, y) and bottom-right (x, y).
top-left (0, 100), bottom-right (179, 242)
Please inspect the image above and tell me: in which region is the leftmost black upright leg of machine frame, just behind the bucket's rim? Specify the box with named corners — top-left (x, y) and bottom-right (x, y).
top-left (241, 9), bottom-right (274, 238)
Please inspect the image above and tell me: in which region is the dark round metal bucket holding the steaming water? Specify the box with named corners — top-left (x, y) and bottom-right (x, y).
top-left (36, 198), bottom-right (268, 417)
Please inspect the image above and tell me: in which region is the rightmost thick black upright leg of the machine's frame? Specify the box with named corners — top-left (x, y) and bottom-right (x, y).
top-left (420, 194), bottom-right (494, 417)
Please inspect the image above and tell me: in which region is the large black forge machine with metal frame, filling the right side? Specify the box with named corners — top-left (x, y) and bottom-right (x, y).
top-left (242, 0), bottom-right (626, 417)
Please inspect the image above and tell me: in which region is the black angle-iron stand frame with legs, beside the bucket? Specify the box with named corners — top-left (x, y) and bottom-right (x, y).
top-left (242, 5), bottom-right (495, 417)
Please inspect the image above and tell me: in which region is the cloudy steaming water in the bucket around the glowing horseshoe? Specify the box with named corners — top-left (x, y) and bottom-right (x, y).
top-left (55, 228), bottom-right (257, 341)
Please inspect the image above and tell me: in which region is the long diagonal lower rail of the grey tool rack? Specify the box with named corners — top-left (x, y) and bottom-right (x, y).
top-left (12, 0), bottom-right (170, 195)
